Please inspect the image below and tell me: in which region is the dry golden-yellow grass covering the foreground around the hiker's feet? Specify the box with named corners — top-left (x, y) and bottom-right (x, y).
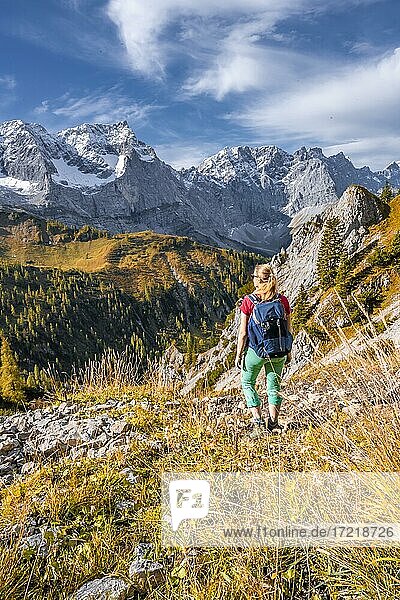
top-left (0, 332), bottom-right (400, 600)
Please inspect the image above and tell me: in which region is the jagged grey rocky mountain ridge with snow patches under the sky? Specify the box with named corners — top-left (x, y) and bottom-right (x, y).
top-left (0, 120), bottom-right (400, 256)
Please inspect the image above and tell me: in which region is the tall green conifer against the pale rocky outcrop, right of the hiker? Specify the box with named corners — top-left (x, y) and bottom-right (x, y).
top-left (317, 218), bottom-right (343, 289)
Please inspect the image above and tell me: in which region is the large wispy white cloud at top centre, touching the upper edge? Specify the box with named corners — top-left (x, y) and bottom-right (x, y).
top-left (106, 0), bottom-right (381, 100)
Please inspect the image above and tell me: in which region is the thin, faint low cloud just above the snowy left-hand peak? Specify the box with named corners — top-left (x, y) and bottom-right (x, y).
top-left (34, 86), bottom-right (159, 124)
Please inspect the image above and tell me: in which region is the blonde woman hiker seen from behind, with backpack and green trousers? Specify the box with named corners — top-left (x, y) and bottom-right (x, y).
top-left (235, 264), bottom-right (293, 438)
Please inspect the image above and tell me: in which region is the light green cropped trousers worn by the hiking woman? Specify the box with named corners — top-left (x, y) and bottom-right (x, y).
top-left (242, 348), bottom-right (286, 408)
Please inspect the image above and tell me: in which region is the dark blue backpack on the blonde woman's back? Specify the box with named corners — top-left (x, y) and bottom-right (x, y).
top-left (247, 294), bottom-right (293, 358)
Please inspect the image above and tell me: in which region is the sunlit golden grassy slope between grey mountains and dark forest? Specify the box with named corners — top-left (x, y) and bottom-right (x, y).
top-left (0, 224), bottom-right (255, 298)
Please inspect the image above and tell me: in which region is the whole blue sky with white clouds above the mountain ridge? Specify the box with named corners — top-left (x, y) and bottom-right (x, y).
top-left (0, 0), bottom-right (400, 169)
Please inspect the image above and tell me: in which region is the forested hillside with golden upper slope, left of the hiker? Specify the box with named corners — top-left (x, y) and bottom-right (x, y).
top-left (0, 211), bottom-right (255, 392)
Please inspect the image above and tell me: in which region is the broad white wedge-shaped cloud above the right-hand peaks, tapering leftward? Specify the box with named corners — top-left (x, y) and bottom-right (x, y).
top-left (235, 48), bottom-right (400, 166)
